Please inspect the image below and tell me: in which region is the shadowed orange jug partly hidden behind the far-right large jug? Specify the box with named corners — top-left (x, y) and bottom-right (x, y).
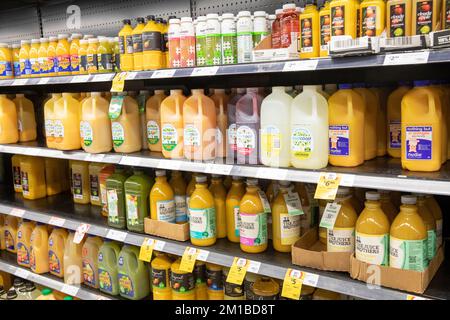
top-left (387, 85), bottom-right (410, 158)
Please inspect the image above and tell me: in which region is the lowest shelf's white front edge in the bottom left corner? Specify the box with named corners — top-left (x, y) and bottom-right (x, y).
top-left (0, 251), bottom-right (116, 300)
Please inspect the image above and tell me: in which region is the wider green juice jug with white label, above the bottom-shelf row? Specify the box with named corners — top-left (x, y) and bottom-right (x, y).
top-left (125, 170), bottom-right (153, 233)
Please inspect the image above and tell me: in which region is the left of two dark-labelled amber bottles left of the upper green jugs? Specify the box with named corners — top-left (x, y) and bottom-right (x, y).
top-left (71, 161), bottom-right (91, 204)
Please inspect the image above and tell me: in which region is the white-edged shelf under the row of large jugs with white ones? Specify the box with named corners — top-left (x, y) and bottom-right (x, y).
top-left (0, 142), bottom-right (450, 195)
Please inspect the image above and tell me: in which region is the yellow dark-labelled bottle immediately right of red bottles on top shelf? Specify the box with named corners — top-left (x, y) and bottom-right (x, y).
top-left (299, 0), bottom-right (320, 59)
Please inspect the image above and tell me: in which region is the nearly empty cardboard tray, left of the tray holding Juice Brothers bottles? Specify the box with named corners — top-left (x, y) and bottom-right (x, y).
top-left (292, 227), bottom-right (352, 272)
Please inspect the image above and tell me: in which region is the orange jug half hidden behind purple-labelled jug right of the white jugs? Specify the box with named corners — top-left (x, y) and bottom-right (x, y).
top-left (353, 83), bottom-right (379, 160)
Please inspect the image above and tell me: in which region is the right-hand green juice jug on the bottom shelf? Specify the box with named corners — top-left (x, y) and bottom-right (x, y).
top-left (117, 245), bottom-right (150, 300)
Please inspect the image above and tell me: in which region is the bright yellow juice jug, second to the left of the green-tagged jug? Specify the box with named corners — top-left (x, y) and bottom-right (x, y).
top-left (53, 92), bottom-right (81, 150)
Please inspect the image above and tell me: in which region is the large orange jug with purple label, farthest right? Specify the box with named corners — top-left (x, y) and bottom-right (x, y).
top-left (401, 81), bottom-right (442, 171)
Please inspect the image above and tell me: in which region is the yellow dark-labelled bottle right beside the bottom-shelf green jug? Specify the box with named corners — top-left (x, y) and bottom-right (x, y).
top-left (150, 254), bottom-right (172, 300)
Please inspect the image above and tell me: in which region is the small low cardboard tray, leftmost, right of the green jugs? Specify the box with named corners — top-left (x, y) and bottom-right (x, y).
top-left (144, 218), bottom-right (190, 241)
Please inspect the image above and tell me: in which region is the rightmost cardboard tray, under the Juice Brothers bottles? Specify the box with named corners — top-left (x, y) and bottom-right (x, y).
top-left (350, 246), bottom-right (444, 294)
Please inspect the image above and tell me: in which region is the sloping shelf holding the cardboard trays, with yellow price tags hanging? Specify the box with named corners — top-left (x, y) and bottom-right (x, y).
top-left (0, 192), bottom-right (449, 300)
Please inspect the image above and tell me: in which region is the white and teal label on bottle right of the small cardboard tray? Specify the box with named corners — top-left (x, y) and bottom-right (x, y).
top-left (189, 208), bottom-right (216, 240)
